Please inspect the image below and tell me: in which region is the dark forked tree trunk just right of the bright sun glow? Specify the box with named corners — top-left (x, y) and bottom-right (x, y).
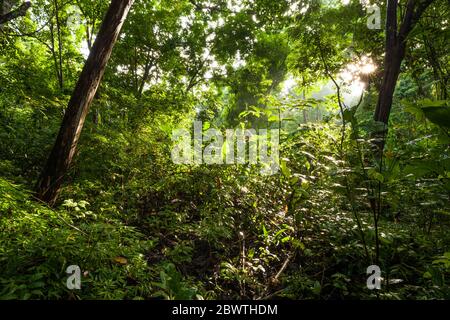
top-left (374, 0), bottom-right (434, 154)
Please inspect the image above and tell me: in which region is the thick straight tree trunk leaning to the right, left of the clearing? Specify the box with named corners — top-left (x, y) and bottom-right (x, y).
top-left (36, 0), bottom-right (134, 205)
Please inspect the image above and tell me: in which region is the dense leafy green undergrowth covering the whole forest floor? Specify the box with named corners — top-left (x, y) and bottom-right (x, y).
top-left (0, 102), bottom-right (450, 299)
